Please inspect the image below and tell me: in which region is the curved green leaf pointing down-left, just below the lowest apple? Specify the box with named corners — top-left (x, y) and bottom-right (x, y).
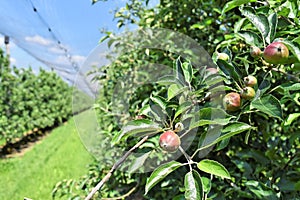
top-left (145, 161), bottom-right (183, 195)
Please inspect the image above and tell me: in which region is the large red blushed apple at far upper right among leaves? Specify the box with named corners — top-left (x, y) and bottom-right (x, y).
top-left (263, 42), bottom-right (289, 64)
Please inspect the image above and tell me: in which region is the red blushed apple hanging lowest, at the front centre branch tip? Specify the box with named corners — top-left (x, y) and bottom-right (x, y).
top-left (159, 130), bottom-right (181, 153)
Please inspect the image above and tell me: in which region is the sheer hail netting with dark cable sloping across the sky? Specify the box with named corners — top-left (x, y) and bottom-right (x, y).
top-left (0, 0), bottom-right (94, 95)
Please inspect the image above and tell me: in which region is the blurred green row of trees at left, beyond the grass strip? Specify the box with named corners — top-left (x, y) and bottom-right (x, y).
top-left (0, 49), bottom-right (72, 143)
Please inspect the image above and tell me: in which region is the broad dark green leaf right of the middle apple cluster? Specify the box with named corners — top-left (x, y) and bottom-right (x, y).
top-left (250, 95), bottom-right (282, 120)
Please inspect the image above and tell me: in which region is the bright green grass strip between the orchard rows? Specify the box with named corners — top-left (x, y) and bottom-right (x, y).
top-left (0, 112), bottom-right (93, 200)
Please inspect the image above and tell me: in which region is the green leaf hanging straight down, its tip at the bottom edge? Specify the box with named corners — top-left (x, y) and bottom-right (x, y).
top-left (184, 170), bottom-right (203, 200)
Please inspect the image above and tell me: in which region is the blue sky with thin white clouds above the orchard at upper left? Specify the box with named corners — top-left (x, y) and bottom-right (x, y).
top-left (0, 0), bottom-right (126, 71)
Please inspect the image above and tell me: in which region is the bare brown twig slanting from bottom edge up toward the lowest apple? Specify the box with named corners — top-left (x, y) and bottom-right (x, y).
top-left (85, 136), bottom-right (148, 200)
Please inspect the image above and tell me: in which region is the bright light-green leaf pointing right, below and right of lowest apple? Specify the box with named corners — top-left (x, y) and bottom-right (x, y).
top-left (197, 159), bottom-right (231, 179)
